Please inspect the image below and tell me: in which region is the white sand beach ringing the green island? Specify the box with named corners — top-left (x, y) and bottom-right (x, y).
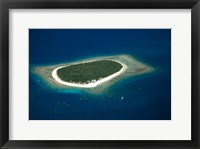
top-left (52, 60), bottom-right (127, 88)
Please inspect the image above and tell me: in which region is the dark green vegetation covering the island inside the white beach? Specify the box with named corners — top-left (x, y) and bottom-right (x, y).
top-left (57, 60), bottom-right (123, 84)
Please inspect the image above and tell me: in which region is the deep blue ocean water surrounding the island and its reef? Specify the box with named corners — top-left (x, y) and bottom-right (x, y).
top-left (29, 29), bottom-right (171, 120)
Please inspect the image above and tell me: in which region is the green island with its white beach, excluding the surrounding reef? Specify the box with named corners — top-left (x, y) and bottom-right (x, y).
top-left (52, 60), bottom-right (127, 88)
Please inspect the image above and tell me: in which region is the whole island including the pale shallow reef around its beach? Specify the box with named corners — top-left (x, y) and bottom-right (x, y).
top-left (31, 55), bottom-right (154, 93)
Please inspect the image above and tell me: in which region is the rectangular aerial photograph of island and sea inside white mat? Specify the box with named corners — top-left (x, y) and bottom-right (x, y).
top-left (29, 29), bottom-right (171, 120)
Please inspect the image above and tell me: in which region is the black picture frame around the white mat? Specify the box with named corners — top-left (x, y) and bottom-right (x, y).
top-left (0, 0), bottom-right (200, 149)
